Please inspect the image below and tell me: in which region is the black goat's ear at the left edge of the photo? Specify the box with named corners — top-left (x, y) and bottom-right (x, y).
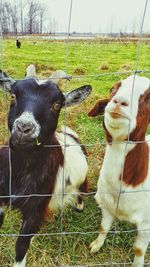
top-left (0, 70), bottom-right (15, 92)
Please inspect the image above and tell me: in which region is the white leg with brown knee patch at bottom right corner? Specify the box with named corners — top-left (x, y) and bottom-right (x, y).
top-left (132, 224), bottom-right (150, 267)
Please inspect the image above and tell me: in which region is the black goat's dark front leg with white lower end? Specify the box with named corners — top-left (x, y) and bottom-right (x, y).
top-left (14, 212), bottom-right (44, 267)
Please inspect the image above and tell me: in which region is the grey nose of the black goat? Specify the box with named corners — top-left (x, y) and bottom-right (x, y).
top-left (16, 121), bottom-right (35, 137)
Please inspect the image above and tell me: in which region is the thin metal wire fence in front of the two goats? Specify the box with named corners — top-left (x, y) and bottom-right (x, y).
top-left (0, 0), bottom-right (150, 267)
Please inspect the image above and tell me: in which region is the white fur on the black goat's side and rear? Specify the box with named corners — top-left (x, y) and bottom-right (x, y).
top-left (49, 127), bottom-right (88, 213)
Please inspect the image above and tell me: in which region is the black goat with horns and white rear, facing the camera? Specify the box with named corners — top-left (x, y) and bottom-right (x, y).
top-left (0, 66), bottom-right (91, 267)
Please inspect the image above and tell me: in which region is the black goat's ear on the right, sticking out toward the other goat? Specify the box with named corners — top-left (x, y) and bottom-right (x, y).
top-left (63, 85), bottom-right (92, 107)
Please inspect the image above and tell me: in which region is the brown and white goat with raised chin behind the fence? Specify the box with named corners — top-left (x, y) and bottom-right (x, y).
top-left (89, 75), bottom-right (150, 267)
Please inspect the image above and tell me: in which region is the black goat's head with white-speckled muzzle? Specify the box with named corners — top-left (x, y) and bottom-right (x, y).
top-left (4, 66), bottom-right (91, 148)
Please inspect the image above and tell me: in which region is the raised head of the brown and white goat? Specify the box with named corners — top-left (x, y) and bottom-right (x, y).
top-left (89, 75), bottom-right (150, 141)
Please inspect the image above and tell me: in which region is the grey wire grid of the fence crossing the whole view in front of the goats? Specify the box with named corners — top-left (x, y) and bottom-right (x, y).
top-left (0, 0), bottom-right (150, 267)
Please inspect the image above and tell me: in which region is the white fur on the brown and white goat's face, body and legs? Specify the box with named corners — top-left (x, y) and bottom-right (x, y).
top-left (90, 76), bottom-right (150, 267)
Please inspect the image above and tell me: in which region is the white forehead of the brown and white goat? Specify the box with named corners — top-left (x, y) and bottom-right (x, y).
top-left (117, 75), bottom-right (150, 98)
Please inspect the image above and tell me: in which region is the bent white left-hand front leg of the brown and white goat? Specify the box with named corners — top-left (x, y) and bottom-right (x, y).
top-left (90, 208), bottom-right (114, 253)
